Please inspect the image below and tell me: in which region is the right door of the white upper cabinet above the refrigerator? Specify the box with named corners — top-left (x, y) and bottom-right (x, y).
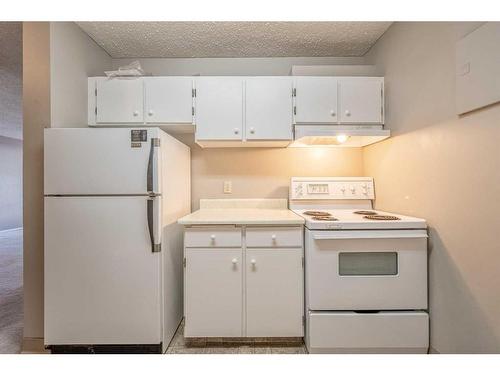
top-left (144, 77), bottom-right (193, 124)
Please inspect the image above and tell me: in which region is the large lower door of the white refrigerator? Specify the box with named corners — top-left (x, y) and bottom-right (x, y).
top-left (44, 196), bottom-right (162, 345)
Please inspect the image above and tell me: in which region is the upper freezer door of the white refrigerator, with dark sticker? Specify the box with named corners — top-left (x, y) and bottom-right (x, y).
top-left (44, 128), bottom-right (161, 195)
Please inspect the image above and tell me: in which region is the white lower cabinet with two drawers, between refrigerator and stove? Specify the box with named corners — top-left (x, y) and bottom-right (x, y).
top-left (184, 225), bottom-right (304, 338)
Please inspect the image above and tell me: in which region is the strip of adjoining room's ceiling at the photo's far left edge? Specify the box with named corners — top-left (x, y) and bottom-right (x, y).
top-left (0, 22), bottom-right (23, 139)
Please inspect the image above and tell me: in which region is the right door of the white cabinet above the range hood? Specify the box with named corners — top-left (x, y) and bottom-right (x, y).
top-left (339, 77), bottom-right (383, 124)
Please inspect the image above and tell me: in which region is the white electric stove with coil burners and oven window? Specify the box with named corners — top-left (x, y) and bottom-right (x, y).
top-left (290, 177), bottom-right (429, 353)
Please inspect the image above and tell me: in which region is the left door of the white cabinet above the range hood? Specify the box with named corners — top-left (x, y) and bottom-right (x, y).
top-left (295, 77), bottom-right (338, 124)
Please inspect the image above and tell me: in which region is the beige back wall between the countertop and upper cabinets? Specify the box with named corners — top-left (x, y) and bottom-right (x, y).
top-left (191, 142), bottom-right (363, 210)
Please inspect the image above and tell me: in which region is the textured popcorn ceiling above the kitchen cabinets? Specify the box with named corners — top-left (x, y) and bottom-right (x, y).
top-left (78, 22), bottom-right (391, 58)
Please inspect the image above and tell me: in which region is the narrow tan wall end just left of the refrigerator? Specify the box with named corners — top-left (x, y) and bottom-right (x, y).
top-left (23, 22), bottom-right (50, 337)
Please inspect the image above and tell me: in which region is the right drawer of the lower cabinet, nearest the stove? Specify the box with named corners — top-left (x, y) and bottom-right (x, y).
top-left (246, 227), bottom-right (302, 247)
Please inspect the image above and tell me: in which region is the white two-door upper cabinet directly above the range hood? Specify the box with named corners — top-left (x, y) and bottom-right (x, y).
top-left (294, 77), bottom-right (384, 124)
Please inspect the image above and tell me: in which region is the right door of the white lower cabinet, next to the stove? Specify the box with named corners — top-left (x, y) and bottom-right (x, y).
top-left (246, 248), bottom-right (304, 337)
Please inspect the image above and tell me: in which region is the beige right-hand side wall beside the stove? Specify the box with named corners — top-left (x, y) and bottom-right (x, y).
top-left (363, 23), bottom-right (500, 353)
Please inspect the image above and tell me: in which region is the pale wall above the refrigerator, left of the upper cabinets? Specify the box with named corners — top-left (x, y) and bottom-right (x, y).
top-left (50, 22), bottom-right (112, 128)
